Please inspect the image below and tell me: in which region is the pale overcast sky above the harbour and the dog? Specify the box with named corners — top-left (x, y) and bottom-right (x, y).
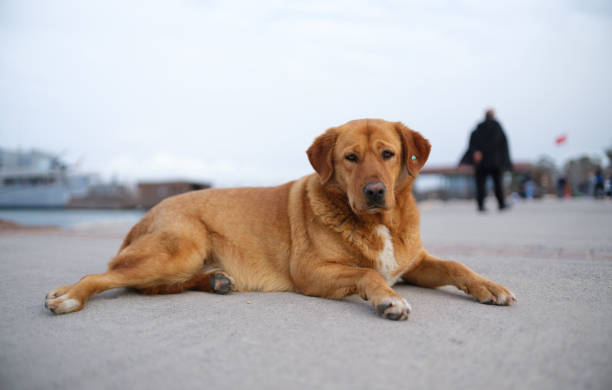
top-left (0, 0), bottom-right (612, 185)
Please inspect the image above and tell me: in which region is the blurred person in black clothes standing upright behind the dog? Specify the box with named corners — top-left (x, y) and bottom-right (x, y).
top-left (460, 109), bottom-right (512, 211)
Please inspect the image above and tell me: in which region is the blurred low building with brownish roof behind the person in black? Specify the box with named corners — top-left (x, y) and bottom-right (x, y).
top-left (414, 163), bottom-right (533, 200)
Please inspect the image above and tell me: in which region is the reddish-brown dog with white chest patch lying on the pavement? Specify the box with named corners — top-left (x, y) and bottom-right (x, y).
top-left (45, 119), bottom-right (516, 320)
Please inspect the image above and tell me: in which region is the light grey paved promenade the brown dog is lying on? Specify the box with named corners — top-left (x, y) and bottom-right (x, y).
top-left (0, 199), bottom-right (612, 390)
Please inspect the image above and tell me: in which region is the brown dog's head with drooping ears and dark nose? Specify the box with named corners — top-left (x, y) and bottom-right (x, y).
top-left (307, 119), bottom-right (431, 214)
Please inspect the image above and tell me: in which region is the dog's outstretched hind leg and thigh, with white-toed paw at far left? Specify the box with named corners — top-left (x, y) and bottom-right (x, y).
top-left (45, 231), bottom-right (210, 314)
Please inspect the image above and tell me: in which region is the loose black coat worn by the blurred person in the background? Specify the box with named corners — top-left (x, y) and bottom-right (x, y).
top-left (460, 119), bottom-right (512, 170)
